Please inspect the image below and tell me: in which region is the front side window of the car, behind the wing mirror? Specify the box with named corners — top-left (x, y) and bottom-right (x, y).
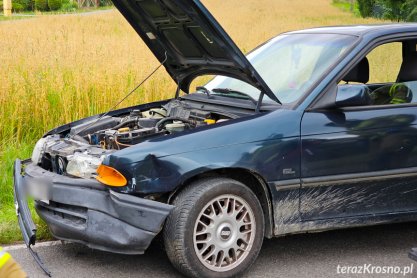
top-left (339, 40), bottom-right (417, 105)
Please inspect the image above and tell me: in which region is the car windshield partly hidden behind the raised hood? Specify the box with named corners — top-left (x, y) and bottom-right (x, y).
top-left (205, 34), bottom-right (357, 103)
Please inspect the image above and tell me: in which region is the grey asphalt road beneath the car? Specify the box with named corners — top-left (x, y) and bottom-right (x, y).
top-left (7, 223), bottom-right (417, 278)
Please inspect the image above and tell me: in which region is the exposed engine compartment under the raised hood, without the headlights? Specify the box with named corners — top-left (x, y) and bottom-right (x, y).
top-left (67, 100), bottom-right (233, 150)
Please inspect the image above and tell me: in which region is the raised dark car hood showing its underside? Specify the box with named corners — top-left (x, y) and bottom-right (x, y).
top-left (112, 0), bottom-right (277, 100)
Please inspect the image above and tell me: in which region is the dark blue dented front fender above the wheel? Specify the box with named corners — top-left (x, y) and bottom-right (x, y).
top-left (104, 110), bottom-right (301, 194)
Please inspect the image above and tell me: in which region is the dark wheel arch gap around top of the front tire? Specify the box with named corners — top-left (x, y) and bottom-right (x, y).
top-left (168, 168), bottom-right (274, 238)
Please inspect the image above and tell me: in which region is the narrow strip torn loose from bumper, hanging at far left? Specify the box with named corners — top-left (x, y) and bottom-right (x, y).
top-left (13, 160), bottom-right (51, 277)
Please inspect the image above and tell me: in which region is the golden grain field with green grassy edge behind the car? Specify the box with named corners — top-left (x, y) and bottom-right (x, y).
top-left (0, 0), bottom-right (386, 244)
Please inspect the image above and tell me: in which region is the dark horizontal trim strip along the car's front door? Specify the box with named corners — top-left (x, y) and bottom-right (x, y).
top-left (301, 167), bottom-right (417, 188)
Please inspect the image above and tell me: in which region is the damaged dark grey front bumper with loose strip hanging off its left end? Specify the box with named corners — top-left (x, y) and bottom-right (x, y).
top-left (14, 160), bottom-right (174, 254)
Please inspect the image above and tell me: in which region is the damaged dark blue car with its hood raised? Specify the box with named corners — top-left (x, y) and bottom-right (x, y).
top-left (14, 0), bottom-right (417, 277)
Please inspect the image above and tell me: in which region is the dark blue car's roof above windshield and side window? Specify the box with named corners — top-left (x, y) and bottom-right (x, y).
top-left (285, 23), bottom-right (417, 37)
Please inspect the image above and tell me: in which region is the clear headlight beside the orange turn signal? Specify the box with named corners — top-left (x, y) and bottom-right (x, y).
top-left (67, 153), bottom-right (104, 179)
